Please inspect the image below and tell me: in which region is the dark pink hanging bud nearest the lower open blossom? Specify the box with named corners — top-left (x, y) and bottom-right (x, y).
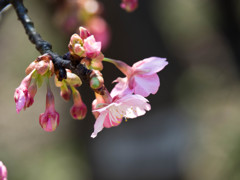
top-left (70, 87), bottom-right (87, 120)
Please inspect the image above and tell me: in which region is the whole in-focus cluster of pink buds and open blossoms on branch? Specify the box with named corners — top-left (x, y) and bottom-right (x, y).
top-left (14, 27), bottom-right (168, 138)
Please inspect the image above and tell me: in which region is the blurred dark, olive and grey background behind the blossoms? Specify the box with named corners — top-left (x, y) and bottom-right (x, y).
top-left (0, 0), bottom-right (240, 180)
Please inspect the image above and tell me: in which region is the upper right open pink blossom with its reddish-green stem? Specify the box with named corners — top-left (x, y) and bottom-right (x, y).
top-left (109, 57), bottom-right (168, 97)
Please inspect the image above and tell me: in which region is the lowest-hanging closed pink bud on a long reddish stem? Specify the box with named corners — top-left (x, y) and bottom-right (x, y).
top-left (39, 84), bottom-right (59, 132)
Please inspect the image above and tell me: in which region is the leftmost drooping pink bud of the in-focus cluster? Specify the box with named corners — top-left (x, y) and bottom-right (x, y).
top-left (14, 73), bottom-right (33, 113)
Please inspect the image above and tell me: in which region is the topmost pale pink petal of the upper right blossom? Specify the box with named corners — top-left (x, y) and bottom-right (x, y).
top-left (132, 57), bottom-right (168, 75)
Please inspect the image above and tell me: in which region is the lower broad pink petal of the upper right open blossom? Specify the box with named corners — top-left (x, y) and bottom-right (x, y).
top-left (133, 74), bottom-right (160, 97)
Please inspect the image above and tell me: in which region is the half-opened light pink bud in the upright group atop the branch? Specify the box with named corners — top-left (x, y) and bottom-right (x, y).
top-left (83, 35), bottom-right (101, 59)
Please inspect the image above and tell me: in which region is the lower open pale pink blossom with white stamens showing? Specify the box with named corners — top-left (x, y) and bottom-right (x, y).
top-left (91, 94), bottom-right (151, 138)
